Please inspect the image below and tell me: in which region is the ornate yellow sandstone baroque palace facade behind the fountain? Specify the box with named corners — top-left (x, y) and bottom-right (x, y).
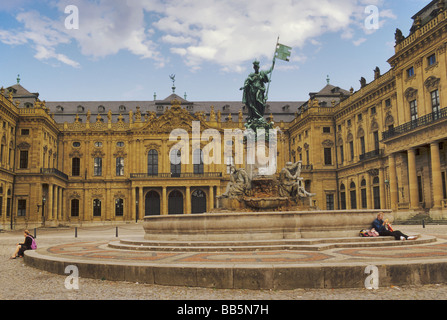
top-left (0, 0), bottom-right (447, 229)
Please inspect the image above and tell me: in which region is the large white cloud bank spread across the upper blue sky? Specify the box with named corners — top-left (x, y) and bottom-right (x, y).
top-left (0, 0), bottom-right (394, 72)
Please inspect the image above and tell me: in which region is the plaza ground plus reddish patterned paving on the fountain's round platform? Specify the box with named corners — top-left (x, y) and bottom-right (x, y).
top-left (0, 224), bottom-right (447, 300)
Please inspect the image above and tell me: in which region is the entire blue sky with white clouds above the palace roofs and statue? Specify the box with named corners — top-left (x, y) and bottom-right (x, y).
top-left (0, 0), bottom-right (431, 101)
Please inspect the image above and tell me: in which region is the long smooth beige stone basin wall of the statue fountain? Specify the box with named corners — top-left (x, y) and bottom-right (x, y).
top-left (143, 210), bottom-right (394, 241)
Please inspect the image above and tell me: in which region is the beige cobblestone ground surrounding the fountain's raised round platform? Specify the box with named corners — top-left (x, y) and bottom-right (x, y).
top-left (0, 224), bottom-right (447, 300)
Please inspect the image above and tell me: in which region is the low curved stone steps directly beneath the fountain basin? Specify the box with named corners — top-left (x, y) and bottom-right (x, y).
top-left (108, 236), bottom-right (436, 252)
